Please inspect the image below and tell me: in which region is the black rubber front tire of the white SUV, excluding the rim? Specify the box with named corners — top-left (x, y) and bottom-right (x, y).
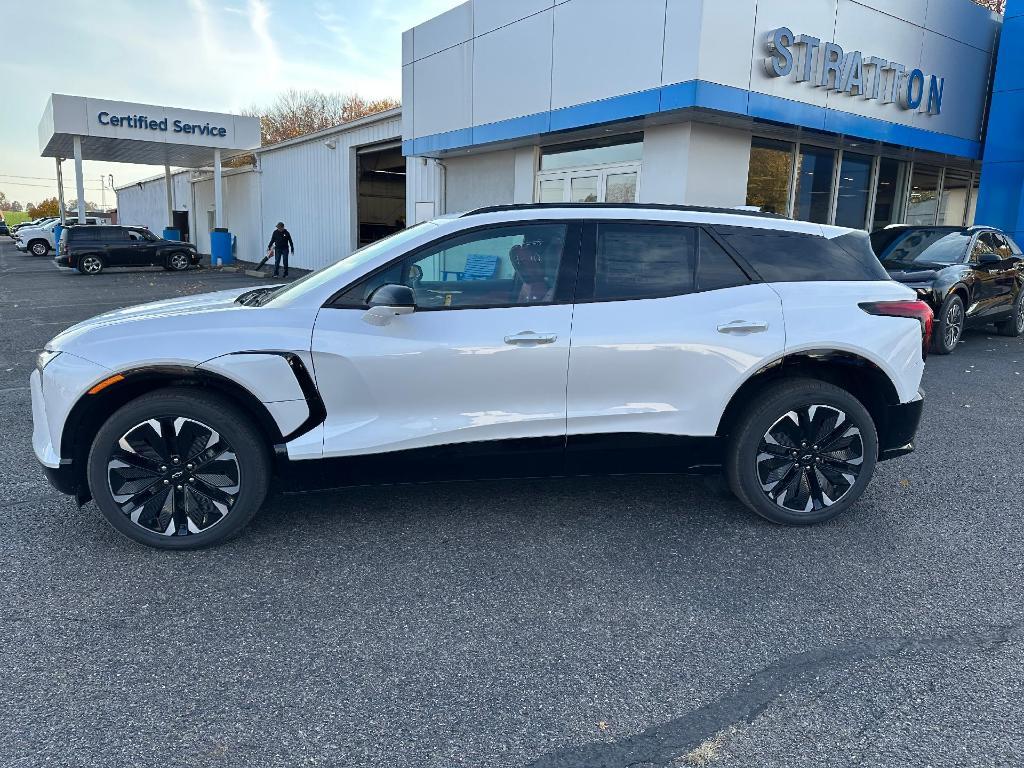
top-left (86, 390), bottom-right (270, 550)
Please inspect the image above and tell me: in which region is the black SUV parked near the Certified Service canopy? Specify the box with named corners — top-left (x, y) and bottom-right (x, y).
top-left (55, 225), bottom-right (200, 274)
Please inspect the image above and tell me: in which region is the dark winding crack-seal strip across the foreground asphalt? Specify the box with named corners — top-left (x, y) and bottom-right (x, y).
top-left (527, 625), bottom-right (1021, 768)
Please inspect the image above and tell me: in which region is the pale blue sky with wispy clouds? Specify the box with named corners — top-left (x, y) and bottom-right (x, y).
top-left (0, 0), bottom-right (460, 206)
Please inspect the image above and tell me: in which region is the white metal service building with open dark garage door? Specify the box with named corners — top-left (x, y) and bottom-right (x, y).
top-left (117, 110), bottom-right (437, 269)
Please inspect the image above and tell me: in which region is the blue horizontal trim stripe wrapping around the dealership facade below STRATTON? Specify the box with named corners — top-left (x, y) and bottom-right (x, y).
top-left (401, 80), bottom-right (981, 160)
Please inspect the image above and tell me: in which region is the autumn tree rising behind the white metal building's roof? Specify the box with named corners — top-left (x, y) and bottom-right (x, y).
top-left (244, 88), bottom-right (400, 144)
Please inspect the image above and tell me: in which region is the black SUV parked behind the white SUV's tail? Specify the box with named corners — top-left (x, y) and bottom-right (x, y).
top-left (871, 225), bottom-right (1024, 354)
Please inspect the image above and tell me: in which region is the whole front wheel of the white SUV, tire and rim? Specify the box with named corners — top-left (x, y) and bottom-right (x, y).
top-left (87, 388), bottom-right (270, 550)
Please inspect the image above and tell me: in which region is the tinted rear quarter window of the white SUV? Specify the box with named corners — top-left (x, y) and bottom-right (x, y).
top-left (715, 226), bottom-right (889, 283)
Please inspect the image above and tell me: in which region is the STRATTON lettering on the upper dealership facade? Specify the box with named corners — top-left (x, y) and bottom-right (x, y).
top-left (764, 27), bottom-right (945, 115)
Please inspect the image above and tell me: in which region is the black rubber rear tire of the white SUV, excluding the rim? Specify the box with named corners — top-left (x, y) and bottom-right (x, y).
top-left (727, 379), bottom-right (879, 525)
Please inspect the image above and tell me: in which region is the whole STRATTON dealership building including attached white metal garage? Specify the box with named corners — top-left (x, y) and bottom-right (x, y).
top-left (119, 0), bottom-right (1024, 267)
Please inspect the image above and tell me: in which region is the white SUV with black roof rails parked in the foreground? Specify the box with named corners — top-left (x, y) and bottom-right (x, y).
top-left (32, 205), bottom-right (932, 549)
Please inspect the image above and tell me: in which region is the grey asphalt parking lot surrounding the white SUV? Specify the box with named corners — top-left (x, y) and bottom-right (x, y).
top-left (0, 239), bottom-right (1024, 768)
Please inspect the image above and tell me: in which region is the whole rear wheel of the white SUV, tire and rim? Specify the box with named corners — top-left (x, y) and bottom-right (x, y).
top-left (725, 379), bottom-right (879, 525)
